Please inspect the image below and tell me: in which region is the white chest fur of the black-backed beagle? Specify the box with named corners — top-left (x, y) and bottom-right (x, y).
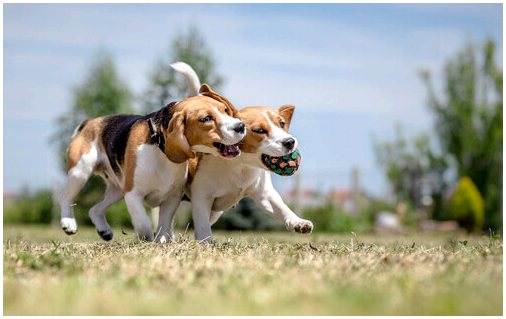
top-left (134, 144), bottom-right (188, 207)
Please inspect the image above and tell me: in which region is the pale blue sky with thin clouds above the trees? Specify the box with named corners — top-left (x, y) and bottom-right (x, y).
top-left (3, 4), bottom-right (503, 196)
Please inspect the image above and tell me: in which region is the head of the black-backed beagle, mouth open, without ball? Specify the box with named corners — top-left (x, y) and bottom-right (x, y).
top-left (159, 84), bottom-right (246, 163)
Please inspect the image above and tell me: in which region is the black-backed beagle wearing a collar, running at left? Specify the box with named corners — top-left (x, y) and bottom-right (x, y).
top-left (60, 80), bottom-right (246, 242)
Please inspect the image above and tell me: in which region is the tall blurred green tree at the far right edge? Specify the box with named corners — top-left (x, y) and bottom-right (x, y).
top-left (422, 41), bottom-right (503, 229)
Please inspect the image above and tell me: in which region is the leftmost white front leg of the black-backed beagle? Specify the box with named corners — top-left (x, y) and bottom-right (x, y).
top-left (125, 190), bottom-right (153, 241)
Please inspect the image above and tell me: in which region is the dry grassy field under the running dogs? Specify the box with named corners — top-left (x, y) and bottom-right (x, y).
top-left (3, 225), bottom-right (503, 315)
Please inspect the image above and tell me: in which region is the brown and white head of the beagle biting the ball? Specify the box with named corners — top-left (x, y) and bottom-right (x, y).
top-left (237, 105), bottom-right (297, 156)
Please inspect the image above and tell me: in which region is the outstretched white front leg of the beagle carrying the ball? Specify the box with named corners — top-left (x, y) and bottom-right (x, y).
top-left (248, 174), bottom-right (313, 233)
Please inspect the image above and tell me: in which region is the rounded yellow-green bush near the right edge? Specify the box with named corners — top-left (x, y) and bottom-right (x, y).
top-left (448, 177), bottom-right (485, 232)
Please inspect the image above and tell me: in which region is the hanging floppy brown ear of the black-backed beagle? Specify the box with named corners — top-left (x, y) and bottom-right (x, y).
top-left (164, 112), bottom-right (195, 163)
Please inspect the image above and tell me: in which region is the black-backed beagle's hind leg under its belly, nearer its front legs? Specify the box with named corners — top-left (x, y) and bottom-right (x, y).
top-left (88, 184), bottom-right (123, 240)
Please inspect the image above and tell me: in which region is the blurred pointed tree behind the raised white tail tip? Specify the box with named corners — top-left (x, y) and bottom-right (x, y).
top-left (142, 27), bottom-right (223, 112)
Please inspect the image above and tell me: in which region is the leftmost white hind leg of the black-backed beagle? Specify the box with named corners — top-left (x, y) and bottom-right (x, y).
top-left (60, 142), bottom-right (98, 235)
